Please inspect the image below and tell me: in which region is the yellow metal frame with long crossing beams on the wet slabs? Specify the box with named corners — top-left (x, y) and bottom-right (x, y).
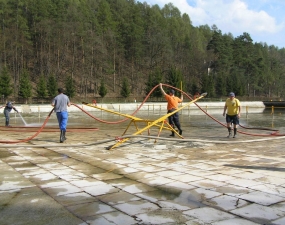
top-left (82, 93), bottom-right (207, 150)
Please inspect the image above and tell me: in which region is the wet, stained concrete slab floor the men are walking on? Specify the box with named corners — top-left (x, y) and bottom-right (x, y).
top-left (0, 108), bottom-right (285, 225)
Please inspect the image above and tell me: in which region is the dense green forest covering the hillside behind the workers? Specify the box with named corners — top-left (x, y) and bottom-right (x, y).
top-left (0, 0), bottom-right (285, 101)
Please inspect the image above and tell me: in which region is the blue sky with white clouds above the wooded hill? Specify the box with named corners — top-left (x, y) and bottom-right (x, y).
top-left (142, 0), bottom-right (285, 48)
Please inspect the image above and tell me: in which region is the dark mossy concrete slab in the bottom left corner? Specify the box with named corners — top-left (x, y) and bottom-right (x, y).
top-left (0, 187), bottom-right (84, 225)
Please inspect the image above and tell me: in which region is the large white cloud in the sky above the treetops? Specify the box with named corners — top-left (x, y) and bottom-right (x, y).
top-left (145, 0), bottom-right (284, 34)
